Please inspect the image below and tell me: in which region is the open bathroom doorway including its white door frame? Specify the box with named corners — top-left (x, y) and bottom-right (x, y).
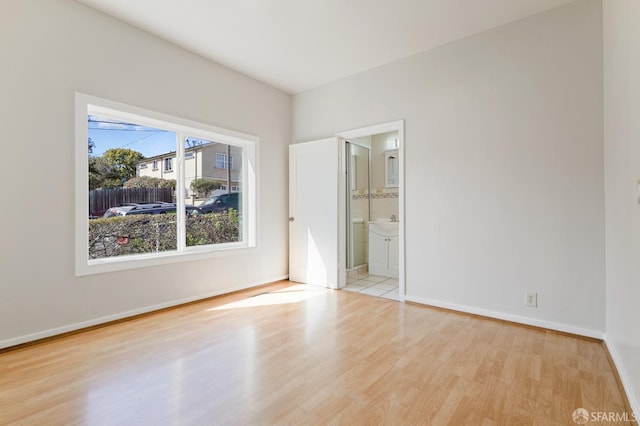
top-left (337, 121), bottom-right (405, 301)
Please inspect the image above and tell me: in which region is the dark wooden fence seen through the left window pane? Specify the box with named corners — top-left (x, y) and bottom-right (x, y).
top-left (89, 188), bottom-right (173, 216)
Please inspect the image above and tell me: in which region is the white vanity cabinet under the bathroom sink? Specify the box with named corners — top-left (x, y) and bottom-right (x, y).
top-left (369, 222), bottom-right (399, 278)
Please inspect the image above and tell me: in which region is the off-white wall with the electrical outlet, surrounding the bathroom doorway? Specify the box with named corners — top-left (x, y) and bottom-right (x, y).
top-left (292, 0), bottom-right (605, 336)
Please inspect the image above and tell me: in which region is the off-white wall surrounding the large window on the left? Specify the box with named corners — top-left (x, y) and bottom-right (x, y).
top-left (0, 0), bottom-right (290, 347)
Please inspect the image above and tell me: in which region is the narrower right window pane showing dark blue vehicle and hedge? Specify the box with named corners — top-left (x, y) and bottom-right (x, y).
top-left (184, 137), bottom-right (243, 246)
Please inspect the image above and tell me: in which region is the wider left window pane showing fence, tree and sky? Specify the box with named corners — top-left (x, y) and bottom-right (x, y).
top-left (88, 115), bottom-right (177, 259)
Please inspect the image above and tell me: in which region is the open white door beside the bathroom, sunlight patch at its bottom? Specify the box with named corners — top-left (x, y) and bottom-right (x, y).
top-left (289, 138), bottom-right (339, 288)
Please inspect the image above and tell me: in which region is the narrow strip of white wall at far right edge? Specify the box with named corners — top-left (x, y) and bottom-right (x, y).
top-left (603, 0), bottom-right (640, 415)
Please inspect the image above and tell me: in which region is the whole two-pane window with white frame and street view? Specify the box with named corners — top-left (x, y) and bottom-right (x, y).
top-left (75, 93), bottom-right (258, 275)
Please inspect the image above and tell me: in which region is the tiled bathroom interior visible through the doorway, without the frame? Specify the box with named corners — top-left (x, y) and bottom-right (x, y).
top-left (344, 131), bottom-right (399, 300)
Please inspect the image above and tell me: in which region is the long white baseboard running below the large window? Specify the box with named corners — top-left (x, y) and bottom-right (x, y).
top-left (0, 275), bottom-right (289, 349)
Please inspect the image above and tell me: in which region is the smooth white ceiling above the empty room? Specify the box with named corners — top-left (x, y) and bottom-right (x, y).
top-left (78, 0), bottom-right (574, 93)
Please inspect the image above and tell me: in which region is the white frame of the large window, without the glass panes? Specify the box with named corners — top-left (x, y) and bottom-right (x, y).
top-left (75, 93), bottom-right (260, 276)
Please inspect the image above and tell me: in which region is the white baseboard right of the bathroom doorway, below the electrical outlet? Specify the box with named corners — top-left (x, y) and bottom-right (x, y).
top-left (404, 296), bottom-right (605, 340)
